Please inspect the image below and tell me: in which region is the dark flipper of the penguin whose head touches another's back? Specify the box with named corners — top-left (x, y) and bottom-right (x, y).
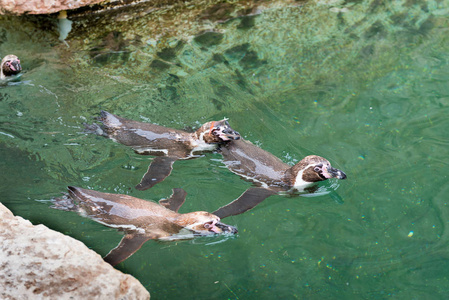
top-left (136, 156), bottom-right (177, 191)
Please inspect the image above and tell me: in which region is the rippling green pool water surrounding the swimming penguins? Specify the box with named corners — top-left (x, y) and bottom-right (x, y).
top-left (0, 0), bottom-right (449, 299)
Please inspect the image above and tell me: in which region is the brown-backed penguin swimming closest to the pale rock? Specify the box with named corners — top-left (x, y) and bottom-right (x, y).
top-left (52, 186), bottom-right (237, 266)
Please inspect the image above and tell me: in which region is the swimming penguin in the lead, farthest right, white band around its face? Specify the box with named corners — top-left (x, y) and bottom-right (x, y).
top-left (213, 139), bottom-right (346, 219)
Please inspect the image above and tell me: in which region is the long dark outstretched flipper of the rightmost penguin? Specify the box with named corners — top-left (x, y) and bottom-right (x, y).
top-left (213, 187), bottom-right (276, 219)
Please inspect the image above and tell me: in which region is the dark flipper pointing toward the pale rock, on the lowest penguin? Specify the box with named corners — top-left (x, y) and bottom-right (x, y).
top-left (103, 233), bottom-right (157, 266)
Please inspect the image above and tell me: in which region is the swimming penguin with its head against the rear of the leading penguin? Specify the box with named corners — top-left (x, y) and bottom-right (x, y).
top-left (91, 111), bottom-right (240, 190)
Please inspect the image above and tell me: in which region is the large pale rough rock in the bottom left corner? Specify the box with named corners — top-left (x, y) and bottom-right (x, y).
top-left (0, 203), bottom-right (150, 299)
